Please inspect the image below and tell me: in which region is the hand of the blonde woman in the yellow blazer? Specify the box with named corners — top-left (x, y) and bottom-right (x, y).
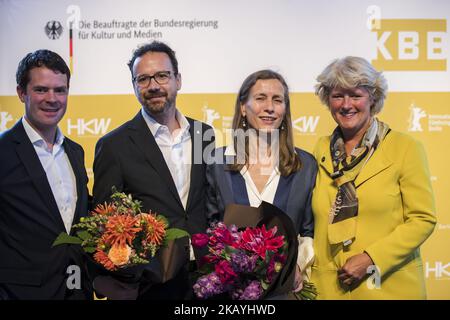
top-left (338, 252), bottom-right (374, 287)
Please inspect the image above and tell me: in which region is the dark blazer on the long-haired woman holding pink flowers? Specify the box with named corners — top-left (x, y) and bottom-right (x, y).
top-left (206, 147), bottom-right (317, 237)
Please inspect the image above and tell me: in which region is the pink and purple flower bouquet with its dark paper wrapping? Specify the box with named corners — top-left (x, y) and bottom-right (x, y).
top-left (192, 202), bottom-right (298, 300)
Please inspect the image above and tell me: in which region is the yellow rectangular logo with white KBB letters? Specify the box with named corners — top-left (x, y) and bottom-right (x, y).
top-left (371, 17), bottom-right (447, 71)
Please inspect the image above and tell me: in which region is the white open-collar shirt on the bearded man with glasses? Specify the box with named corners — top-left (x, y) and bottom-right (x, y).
top-left (141, 108), bottom-right (192, 210)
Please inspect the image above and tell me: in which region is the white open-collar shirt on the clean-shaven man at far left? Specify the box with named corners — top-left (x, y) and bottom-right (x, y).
top-left (22, 118), bottom-right (78, 233)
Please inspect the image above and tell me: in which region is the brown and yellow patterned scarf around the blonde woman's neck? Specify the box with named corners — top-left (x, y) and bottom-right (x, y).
top-left (328, 118), bottom-right (390, 246)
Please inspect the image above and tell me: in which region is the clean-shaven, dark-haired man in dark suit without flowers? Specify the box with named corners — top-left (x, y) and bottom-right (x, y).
top-left (0, 50), bottom-right (89, 299)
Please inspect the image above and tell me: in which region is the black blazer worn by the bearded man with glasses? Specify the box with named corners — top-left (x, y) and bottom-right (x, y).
top-left (93, 111), bottom-right (214, 299)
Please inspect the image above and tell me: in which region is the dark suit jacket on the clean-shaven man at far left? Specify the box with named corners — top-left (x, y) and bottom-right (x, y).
top-left (0, 121), bottom-right (90, 299)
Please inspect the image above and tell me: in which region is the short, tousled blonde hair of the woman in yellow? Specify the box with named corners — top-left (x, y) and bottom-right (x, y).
top-left (315, 56), bottom-right (388, 115)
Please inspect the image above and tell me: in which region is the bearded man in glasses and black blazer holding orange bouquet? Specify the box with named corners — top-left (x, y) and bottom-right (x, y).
top-left (94, 41), bottom-right (214, 299)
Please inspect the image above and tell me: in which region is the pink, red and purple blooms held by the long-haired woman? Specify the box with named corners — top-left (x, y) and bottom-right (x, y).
top-left (192, 222), bottom-right (286, 300)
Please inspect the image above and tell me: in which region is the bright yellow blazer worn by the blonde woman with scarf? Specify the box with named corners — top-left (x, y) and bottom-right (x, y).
top-left (312, 130), bottom-right (436, 299)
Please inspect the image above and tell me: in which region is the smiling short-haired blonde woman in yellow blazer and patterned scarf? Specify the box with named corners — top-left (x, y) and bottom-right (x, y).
top-left (312, 57), bottom-right (436, 299)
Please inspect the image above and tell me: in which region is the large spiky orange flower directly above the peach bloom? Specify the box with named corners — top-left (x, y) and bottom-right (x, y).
top-left (103, 214), bottom-right (142, 246)
